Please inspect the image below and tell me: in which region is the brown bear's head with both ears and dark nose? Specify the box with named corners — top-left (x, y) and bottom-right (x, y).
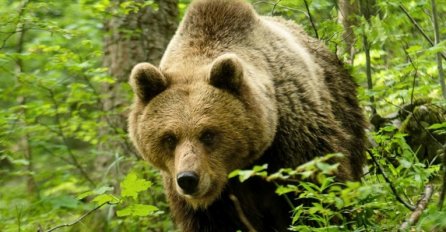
top-left (129, 54), bottom-right (277, 208)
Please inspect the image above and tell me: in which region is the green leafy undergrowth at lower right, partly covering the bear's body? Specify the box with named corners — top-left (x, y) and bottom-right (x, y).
top-left (231, 141), bottom-right (446, 231)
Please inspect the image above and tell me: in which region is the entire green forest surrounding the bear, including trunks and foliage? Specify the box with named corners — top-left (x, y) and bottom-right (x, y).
top-left (0, 0), bottom-right (446, 232)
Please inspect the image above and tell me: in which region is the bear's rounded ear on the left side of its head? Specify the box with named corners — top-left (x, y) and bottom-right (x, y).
top-left (129, 63), bottom-right (167, 103)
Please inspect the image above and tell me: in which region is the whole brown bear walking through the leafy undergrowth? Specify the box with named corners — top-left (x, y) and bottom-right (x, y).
top-left (129, 0), bottom-right (365, 232)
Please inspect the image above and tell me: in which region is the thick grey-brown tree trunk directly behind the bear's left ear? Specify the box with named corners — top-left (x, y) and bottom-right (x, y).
top-left (103, 0), bottom-right (178, 154)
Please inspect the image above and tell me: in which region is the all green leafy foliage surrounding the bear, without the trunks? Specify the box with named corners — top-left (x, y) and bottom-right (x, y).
top-left (0, 0), bottom-right (446, 231)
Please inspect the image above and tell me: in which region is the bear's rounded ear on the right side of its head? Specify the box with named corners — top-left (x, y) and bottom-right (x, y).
top-left (209, 54), bottom-right (243, 94)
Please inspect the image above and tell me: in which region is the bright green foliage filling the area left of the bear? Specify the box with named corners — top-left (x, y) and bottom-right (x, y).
top-left (0, 0), bottom-right (172, 231)
